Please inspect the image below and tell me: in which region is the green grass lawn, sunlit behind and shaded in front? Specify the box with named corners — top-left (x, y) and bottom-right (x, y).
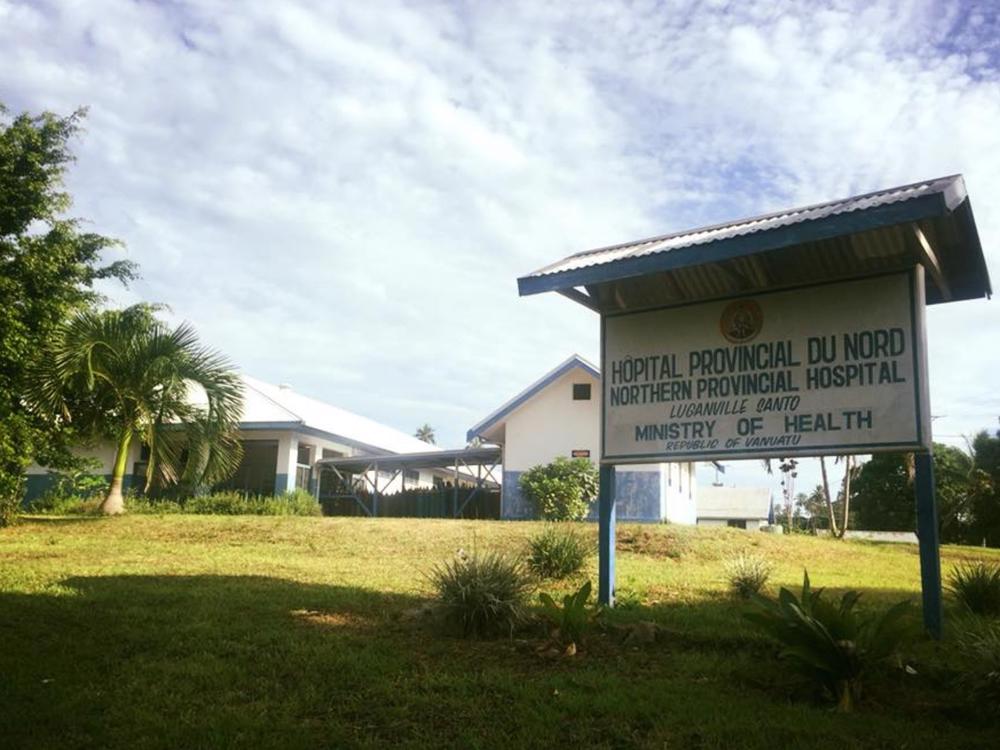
top-left (0, 516), bottom-right (1000, 750)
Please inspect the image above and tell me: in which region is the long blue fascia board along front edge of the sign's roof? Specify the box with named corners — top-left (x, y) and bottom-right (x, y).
top-left (517, 191), bottom-right (957, 297)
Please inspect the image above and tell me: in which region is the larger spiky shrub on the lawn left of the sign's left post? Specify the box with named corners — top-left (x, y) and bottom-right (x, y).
top-left (430, 552), bottom-right (533, 637)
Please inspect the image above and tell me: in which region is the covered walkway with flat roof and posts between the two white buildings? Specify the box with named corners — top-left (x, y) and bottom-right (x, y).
top-left (314, 446), bottom-right (502, 518)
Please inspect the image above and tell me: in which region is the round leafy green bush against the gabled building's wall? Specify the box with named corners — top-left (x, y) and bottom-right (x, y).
top-left (520, 456), bottom-right (598, 521)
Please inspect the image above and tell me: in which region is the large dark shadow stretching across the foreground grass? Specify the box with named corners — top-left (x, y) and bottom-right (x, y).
top-left (0, 575), bottom-right (992, 748)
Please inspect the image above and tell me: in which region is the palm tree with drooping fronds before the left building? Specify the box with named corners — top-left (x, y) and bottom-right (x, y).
top-left (29, 305), bottom-right (243, 514)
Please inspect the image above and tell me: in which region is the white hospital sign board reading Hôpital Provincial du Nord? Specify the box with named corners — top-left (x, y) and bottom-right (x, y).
top-left (601, 267), bottom-right (930, 463)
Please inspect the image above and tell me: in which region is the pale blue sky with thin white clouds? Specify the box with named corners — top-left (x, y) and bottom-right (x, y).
top-left (0, 0), bottom-right (1000, 506)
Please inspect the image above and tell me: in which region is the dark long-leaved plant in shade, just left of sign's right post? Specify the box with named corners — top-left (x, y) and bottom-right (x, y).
top-left (745, 572), bottom-right (915, 711)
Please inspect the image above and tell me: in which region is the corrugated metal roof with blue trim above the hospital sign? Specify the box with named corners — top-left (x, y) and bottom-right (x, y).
top-left (518, 175), bottom-right (991, 312)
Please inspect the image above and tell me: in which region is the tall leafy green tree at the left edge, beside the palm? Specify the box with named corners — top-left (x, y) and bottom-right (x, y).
top-left (0, 104), bottom-right (135, 526)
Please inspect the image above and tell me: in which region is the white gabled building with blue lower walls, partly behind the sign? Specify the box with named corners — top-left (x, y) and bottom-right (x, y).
top-left (467, 354), bottom-right (697, 524)
